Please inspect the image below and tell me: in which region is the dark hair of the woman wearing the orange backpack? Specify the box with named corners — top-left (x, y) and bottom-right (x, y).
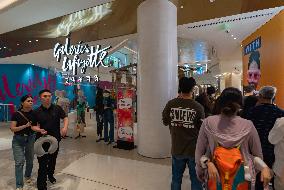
top-left (218, 87), bottom-right (243, 117)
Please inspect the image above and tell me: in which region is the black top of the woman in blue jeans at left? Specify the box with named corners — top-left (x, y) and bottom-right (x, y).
top-left (11, 111), bottom-right (36, 135)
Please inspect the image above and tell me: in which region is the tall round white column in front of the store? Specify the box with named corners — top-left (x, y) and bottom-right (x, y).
top-left (137, 0), bottom-right (178, 158)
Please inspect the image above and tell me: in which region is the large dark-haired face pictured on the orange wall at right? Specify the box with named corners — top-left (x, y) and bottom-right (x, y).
top-left (247, 51), bottom-right (261, 89)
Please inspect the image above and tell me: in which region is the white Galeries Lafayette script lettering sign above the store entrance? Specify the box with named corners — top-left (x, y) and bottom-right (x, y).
top-left (53, 37), bottom-right (111, 75)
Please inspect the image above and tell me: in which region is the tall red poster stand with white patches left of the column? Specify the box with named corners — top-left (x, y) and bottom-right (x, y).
top-left (117, 88), bottom-right (134, 146)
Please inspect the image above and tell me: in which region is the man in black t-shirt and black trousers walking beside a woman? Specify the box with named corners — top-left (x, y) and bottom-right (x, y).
top-left (32, 89), bottom-right (68, 190)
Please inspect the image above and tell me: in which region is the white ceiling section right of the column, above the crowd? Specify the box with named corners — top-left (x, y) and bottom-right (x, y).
top-left (178, 7), bottom-right (283, 72)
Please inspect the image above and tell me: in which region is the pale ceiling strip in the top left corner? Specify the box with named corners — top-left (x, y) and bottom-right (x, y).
top-left (0, 0), bottom-right (112, 34)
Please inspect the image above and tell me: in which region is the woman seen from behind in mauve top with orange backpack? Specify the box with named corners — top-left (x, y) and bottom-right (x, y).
top-left (195, 87), bottom-right (272, 190)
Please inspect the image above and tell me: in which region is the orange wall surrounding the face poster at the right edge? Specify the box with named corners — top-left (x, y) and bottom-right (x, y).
top-left (242, 10), bottom-right (284, 108)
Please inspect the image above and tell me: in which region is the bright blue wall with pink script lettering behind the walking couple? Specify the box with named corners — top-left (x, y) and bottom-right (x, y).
top-left (0, 64), bottom-right (98, 120)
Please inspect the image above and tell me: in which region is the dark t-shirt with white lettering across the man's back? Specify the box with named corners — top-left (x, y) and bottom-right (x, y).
top-left (163, 98), bottom-right (205, 157)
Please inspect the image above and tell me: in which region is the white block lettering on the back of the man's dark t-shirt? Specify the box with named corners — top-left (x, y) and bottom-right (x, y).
top-left (170, 108), bottom-right (196, 129)
